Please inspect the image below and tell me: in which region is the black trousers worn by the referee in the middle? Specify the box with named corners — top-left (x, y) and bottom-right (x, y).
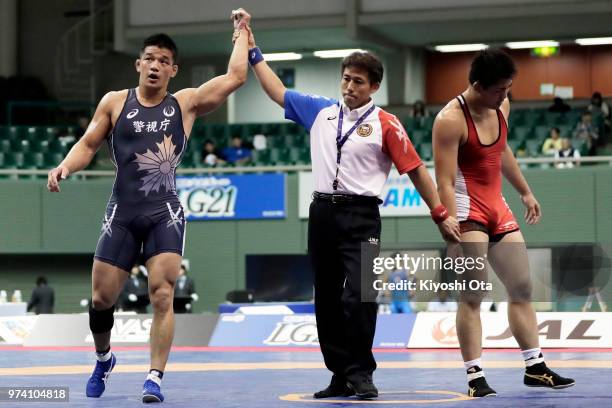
top-left (308, 199), bottom-right (381, 381)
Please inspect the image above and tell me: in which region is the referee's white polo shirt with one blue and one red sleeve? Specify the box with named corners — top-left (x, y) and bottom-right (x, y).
top-left (285, 90), bottom-right (423, 196)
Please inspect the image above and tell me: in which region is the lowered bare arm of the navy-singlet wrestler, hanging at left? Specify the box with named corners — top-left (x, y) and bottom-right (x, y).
top-left (47, 91), bottom-right (118, 192)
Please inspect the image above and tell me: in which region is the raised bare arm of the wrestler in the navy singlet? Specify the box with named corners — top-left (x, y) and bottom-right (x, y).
top-left (175, 9), bottom-right (251, 116)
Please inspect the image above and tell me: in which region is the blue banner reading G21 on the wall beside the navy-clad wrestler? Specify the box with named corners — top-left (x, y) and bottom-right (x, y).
top-left (176, 174), bottom-right (287, 221)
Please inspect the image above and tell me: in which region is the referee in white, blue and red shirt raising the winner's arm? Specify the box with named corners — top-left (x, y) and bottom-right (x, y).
top-left (239, 11), bottom-right (459, 399)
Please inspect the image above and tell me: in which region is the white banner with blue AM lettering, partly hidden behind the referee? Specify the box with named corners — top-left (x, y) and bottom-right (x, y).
top-left (299, 169), bottom-right (435, 218)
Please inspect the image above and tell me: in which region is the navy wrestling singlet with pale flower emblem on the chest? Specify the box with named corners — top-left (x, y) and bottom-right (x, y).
top-left (95, 89), bottom-right (187, 271)
